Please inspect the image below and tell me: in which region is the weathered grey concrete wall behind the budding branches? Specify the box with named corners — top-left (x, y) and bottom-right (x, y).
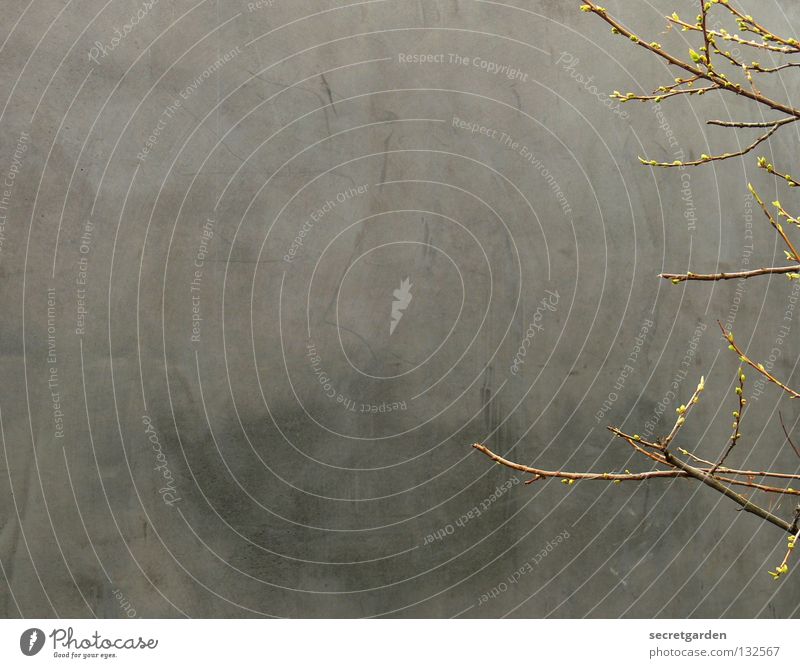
top-left (0, 0), bottom-right (800, 617)
